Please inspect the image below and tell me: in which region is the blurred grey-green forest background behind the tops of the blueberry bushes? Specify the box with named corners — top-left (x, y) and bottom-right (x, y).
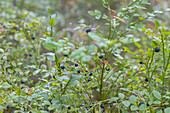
top-left (0, 0), bottom-right (170, 30)
